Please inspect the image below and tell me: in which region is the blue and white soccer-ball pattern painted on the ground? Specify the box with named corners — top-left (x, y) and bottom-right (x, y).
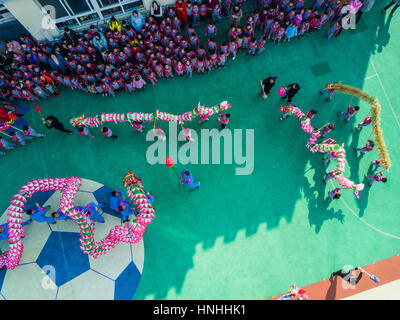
top-left (0, 179), bottom-right (144, 300)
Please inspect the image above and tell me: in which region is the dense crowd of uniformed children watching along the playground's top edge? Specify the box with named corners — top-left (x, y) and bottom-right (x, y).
top-left (0, 0), bottom-right (350, 101)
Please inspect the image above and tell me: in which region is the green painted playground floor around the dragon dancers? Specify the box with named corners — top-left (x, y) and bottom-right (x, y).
top-left (0, 4), bottom-right (400, 299)
